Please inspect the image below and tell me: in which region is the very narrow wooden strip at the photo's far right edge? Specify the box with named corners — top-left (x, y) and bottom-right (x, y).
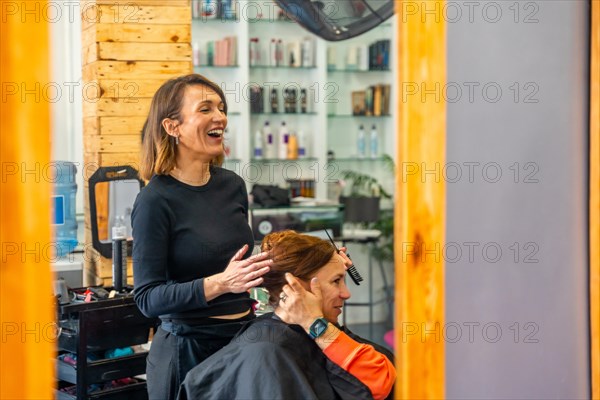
top-left (589, 0), bottom-right (600, 399)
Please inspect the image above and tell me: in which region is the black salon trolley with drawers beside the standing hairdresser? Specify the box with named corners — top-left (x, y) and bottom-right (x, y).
top-left (56, 296), bottom-right (156, 400)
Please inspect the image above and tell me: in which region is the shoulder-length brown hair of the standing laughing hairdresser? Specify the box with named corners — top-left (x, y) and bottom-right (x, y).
top-left (140, 74), bottom-right (227, 180)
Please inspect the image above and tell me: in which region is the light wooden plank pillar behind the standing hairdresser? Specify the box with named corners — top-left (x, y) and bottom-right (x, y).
top-left (81, 0), bottom-right (193, 285)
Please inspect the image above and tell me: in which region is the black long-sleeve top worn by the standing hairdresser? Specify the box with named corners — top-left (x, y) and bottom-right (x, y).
top-left (131, 167), bottom-right (254, 320)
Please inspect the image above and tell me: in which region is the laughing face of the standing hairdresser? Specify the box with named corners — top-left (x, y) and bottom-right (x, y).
top-left (177, 85), bottom-right (227, 162)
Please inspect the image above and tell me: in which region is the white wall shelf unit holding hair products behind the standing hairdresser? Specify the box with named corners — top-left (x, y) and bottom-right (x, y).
top-left (192, 7), bottom-right (397, 198)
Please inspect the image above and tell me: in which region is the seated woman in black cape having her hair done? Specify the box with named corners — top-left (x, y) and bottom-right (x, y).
top-left (179, 231), bottom-right (396, 400)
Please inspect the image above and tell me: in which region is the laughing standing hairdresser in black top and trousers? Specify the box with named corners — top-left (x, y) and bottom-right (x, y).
top-left (132, 74), bottom-right (271, 400)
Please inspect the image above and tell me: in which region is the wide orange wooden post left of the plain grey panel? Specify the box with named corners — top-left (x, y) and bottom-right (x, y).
top-left (394, 0), bottom-right (446, 399)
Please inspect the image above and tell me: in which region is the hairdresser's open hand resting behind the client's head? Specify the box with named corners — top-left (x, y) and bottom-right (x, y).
top-left (204, 245), bottom-right (273, 301)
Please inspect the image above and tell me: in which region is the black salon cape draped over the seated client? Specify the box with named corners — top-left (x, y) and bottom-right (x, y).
top-left (178, 314), bottom-right (389, 400)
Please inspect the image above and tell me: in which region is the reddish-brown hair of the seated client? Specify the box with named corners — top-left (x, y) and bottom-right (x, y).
top-left (261, 231), bottom-right (335, 307)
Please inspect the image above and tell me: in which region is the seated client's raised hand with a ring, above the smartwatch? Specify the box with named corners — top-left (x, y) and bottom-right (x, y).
top-left (278, 273), bottom-right (323, 332)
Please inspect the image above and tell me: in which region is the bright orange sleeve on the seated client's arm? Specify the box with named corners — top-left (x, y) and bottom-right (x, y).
top-left (323, 332), bottom-right (396, 400)
